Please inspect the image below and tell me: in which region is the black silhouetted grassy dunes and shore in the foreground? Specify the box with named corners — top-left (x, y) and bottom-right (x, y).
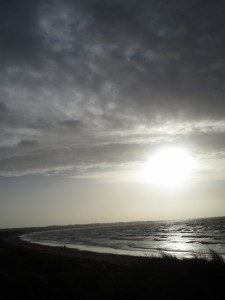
top-left (0, 231), bottom-right (225, 300)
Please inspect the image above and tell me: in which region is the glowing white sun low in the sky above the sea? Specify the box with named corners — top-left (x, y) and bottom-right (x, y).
top-left (141, 148), bottom-right (195, 187)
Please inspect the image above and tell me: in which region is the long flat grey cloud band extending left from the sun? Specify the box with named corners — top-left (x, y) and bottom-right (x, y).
top-left (0, 141), bottom-right (150, 176)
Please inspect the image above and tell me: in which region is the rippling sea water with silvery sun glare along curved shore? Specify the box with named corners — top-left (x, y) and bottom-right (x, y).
top-left (22, 217), bottom-right (225, 258)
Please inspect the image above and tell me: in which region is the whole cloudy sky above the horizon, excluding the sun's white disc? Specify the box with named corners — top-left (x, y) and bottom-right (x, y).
top-left (0, 0), bottom-right (225, 228)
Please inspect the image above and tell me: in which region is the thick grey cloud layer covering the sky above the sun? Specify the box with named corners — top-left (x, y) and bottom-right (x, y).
top-left (0, 0), bottom-right (225, 175)
